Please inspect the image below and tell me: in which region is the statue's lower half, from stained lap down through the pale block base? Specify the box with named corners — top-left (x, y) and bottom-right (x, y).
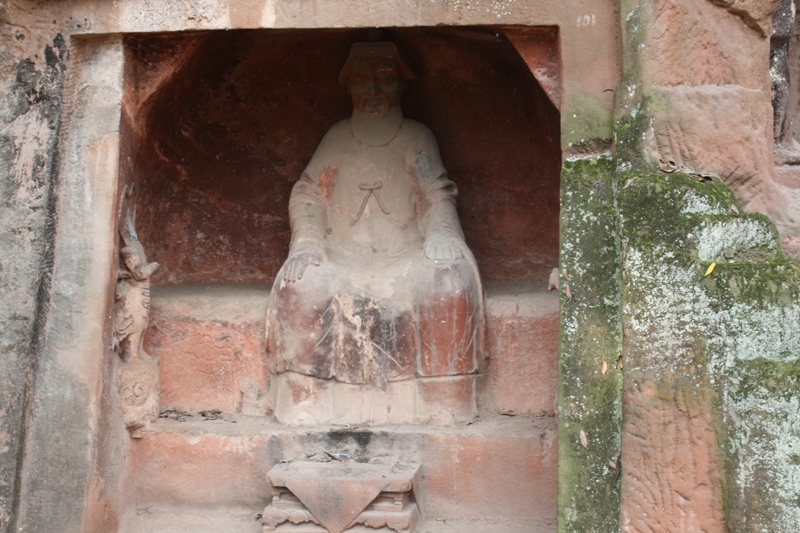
top-left (267, 249), bottom-right (482, 425)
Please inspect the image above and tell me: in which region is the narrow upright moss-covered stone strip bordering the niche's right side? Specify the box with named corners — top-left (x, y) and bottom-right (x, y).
top-left (558, 159), bottom-right (622, 533)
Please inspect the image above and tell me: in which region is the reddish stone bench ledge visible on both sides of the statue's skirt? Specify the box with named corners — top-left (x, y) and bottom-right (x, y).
top-left (145, 282), bottom-right (559, 418)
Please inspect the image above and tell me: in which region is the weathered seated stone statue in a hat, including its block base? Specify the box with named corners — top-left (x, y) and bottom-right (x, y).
top-left (267, 42), bottom-right (484, 424)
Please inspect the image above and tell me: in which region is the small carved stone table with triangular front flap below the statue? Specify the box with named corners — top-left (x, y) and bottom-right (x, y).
top-left (262, 462), bottom-right (420, 533)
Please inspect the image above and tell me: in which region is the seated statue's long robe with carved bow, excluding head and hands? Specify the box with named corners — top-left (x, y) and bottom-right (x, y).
top-left (267, 119), bottom-right (484, 422)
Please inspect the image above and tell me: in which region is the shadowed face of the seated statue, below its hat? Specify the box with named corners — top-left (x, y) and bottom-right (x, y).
top-left (350, 58), bottom-right (403, 116)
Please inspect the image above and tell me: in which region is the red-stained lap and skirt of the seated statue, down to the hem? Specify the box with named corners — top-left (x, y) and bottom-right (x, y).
top-left (268, 249), bottom-right (480, 385)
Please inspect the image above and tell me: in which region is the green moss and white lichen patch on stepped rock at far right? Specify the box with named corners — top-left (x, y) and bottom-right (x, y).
top-left (618, 173), bottom-right (800, 532)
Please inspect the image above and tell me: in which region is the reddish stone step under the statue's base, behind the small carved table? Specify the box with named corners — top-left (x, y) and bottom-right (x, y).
top-left (131, 415), bottom-right (557, 520)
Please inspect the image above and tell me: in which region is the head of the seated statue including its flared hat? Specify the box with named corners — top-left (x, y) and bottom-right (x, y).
top-left (339, 42), bottom-right (417, 116)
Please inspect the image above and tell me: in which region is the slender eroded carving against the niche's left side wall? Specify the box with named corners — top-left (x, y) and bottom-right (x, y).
top-left (112, 207), bottom-right (158, 432)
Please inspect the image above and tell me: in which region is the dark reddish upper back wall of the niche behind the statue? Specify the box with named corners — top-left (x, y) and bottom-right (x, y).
top-left (121, 28), bottom-right (561, 285)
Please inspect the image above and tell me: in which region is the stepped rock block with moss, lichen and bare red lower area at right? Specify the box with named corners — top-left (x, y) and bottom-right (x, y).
top-left (620, 174), bottom-right (800, 532)
